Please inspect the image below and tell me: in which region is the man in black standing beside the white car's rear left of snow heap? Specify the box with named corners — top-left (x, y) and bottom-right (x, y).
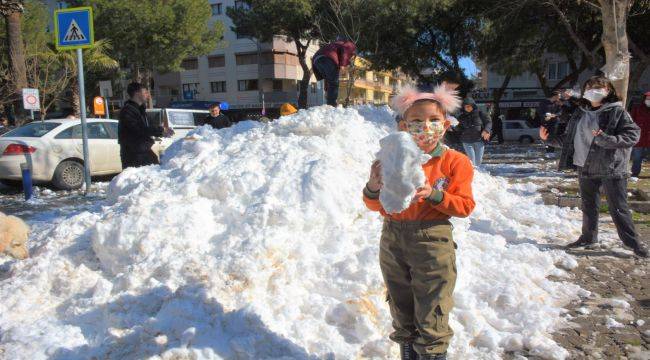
top-left (117, 83), bottom-right (171, 169)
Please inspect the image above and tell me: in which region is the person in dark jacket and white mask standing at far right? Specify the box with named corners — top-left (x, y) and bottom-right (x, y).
top-left (540, 76), bottom-right (648, 257)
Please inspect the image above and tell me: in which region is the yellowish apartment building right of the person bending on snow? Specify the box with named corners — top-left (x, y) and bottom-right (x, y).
top-left (338, 56), bottom-right (415, 105)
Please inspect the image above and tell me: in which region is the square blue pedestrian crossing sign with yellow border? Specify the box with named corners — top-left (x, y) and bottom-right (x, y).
top-left (54, 6), bottom-right (95, 50)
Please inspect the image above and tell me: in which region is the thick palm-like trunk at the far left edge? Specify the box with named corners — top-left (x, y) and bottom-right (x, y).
top-left (0, 0), bottom-right (27, 124)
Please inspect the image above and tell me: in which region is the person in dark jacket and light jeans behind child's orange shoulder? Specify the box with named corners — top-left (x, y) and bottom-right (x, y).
top-left (458, 98), bottom-right (492, 166)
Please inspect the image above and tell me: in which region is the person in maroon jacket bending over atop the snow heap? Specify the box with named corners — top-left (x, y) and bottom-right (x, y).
top-left (312, 40), bottom-right (357, 106)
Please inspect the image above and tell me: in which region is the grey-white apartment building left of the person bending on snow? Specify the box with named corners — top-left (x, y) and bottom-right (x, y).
top-left (153, 0), bottom-right (324, 109)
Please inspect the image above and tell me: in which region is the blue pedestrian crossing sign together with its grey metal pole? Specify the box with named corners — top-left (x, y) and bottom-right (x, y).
top-left (54, 6), bottom-right (95, 195)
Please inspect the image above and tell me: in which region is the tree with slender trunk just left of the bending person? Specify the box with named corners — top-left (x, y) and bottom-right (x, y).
top-left (226, 0), bottom-right (318, 108)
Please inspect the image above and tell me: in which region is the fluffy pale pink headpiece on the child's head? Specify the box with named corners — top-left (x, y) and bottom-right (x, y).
top-left (391, 85), bottom-right (461, 119)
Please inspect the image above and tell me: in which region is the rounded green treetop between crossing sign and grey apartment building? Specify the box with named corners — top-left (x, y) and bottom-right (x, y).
top-left (88, 0), bottom-right (223, 97)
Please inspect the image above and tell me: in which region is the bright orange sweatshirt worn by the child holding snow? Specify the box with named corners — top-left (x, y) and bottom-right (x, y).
top-left (363, 146), bottom-right (476, 221)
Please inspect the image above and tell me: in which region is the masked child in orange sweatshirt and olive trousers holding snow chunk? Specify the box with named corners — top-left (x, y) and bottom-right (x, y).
top-left (363, 86), bottom-right (475, 360)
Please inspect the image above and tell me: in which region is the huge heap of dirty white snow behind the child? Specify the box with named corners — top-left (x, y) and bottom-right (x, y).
top-left (0, 106), bottom-right (586, 359)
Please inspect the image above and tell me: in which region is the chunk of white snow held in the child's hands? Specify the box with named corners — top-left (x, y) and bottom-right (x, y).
top-left (377, 131), bottom-right (431, 214)
